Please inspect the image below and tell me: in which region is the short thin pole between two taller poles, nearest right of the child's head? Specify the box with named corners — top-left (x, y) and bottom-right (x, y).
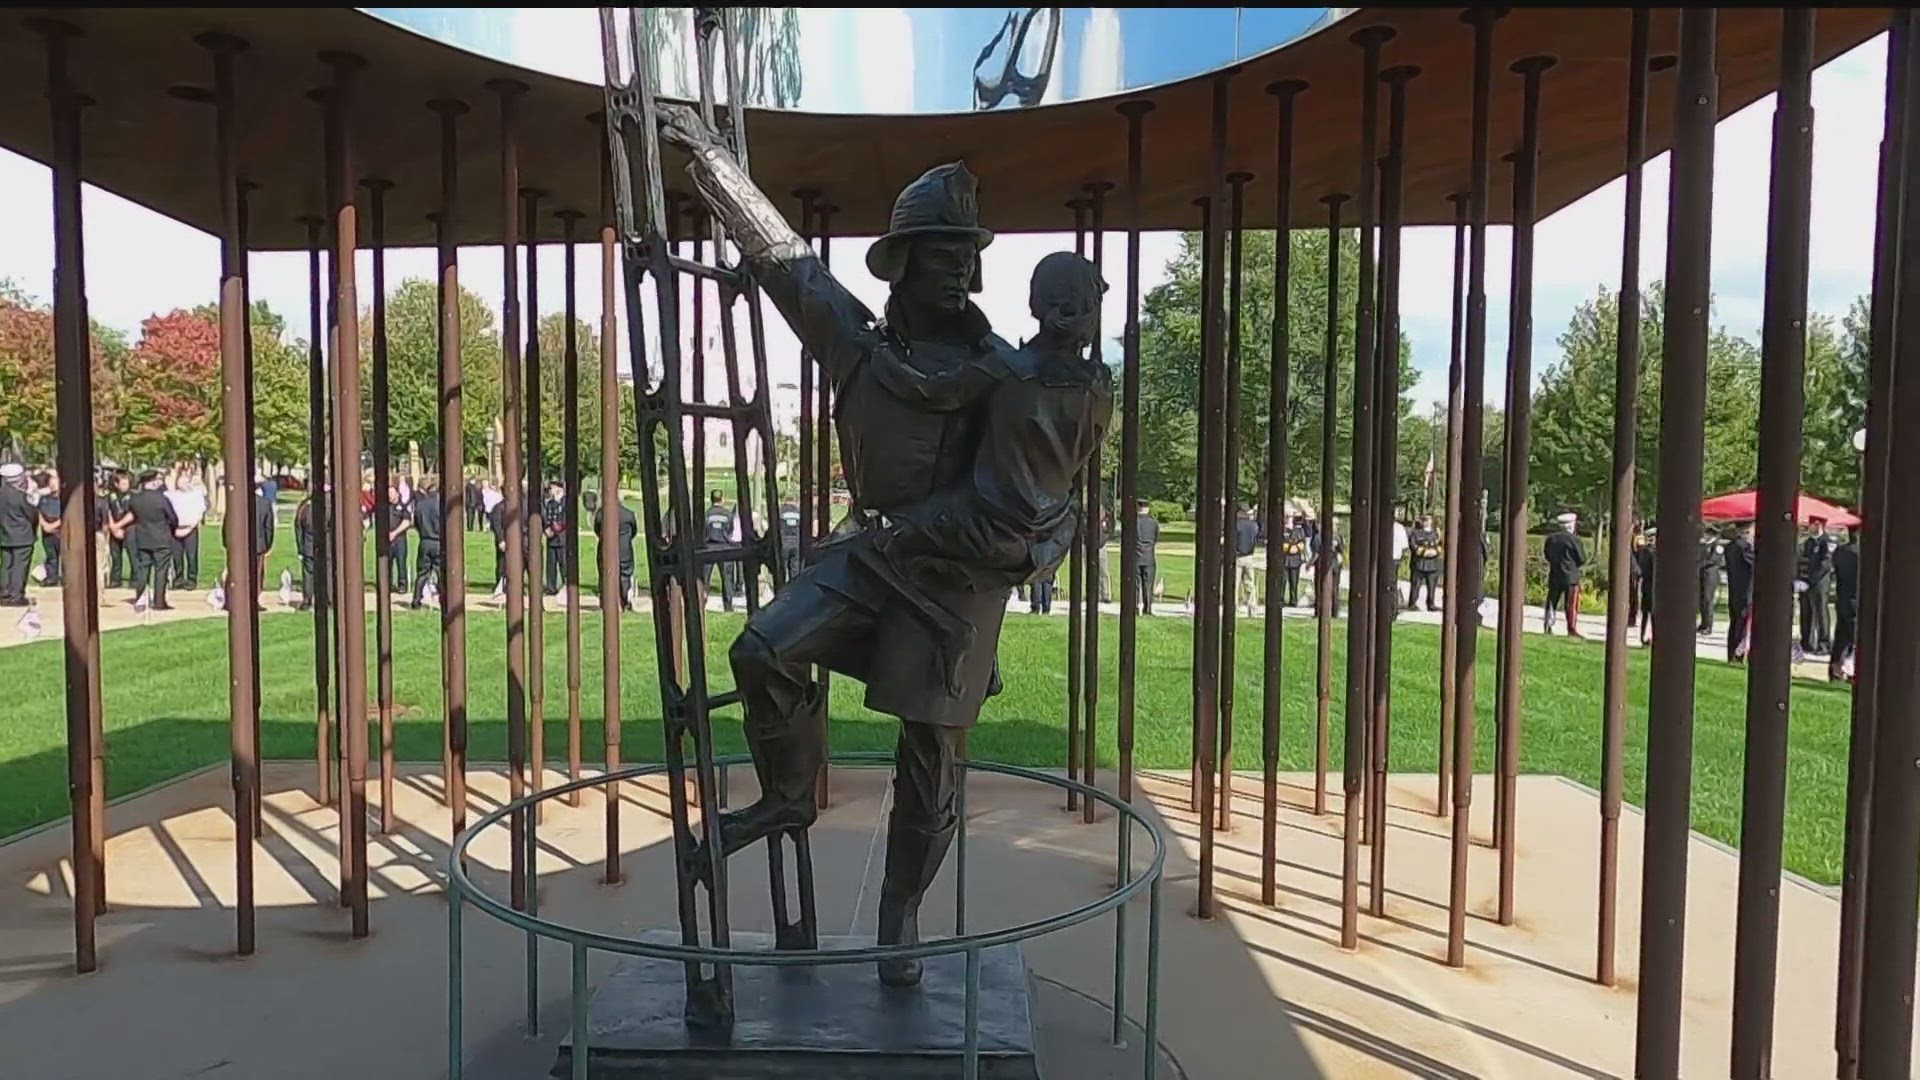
top-left (1215, 171), bottom-right (1254, 834)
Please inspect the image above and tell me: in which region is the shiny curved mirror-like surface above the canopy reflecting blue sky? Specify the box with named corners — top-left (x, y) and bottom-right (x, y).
top-left (363, 8), bottom-right (1354, 113)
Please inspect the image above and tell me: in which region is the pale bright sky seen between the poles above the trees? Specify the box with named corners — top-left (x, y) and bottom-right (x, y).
top-left (0, 19), bottom-right (1885, 424)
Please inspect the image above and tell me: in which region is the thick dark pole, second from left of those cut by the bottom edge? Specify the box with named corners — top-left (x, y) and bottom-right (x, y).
top-left (1728, 8), bottom-right (1814, 1080)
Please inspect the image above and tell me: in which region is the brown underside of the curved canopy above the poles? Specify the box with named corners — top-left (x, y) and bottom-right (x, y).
top-left (0, 6), bottom-right (1889, 250)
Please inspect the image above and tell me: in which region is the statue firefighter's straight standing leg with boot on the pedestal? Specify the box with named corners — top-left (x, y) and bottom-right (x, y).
top-left (879, 723), bottom-right (966, 986)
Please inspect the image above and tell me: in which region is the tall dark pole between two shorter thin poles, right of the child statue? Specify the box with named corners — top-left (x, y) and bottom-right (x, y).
top-left (1260, 79), bottom-right (1305, 907)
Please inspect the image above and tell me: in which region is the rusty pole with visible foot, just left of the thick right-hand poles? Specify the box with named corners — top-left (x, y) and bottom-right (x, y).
top-left (1594, 18), bottom-right (1653, 986)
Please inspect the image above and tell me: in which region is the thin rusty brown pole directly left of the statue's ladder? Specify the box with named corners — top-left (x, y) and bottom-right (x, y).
top-left (588, 113), bottom-right (625, 886)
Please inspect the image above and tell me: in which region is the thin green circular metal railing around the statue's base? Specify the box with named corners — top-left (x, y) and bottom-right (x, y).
top-left (447, 753), bottom-right (1167, 1080)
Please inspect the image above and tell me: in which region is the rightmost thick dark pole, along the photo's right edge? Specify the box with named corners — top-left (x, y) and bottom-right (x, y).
top-left (1859, 18), bottom-right (1920, 1078)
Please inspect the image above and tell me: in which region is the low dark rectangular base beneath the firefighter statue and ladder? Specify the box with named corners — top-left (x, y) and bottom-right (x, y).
top-left (553, 932), bottom-right (1039, 1080)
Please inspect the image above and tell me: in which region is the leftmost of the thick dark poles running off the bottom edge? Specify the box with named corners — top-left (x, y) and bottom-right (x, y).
top-left (1634, 8), bottom-right (1720, 1080)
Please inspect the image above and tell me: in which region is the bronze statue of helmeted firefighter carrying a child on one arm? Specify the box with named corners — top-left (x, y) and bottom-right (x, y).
top-left (660, 104), bottom-right (1112, 986)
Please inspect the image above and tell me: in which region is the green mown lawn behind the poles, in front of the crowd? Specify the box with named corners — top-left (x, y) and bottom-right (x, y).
top-left (0, 599), bottom-right (1849, 882)
